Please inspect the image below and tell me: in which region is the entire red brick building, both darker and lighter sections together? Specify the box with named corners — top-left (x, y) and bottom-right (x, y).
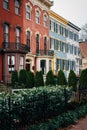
top-left (0, 0), bottom-right (53, 82)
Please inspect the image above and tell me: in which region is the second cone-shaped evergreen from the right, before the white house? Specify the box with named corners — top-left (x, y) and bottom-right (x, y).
top-left (68, 70), bottom-right (77, 90)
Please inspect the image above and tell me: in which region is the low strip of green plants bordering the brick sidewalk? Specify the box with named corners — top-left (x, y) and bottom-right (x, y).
top-left (28, 103), bottom-right (87, 130)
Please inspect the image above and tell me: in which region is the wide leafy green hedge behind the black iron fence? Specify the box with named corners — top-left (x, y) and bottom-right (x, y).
top-left (1, 86), bottom-right (71, 125)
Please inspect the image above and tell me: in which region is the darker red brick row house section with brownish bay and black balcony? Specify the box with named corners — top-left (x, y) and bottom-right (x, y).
top-left (0, 0), bottom-right (28, 82)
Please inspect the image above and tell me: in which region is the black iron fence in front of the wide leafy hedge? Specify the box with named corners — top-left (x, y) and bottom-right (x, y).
top-left (0, 89), bottom-right (67, 130)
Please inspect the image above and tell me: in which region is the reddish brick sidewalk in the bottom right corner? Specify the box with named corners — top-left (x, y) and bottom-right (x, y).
top-left (61, 117), bottom-right (87, 130)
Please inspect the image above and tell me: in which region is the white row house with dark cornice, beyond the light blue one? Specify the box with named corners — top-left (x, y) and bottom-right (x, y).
top-left (66, 22), bottom-right (81, 76)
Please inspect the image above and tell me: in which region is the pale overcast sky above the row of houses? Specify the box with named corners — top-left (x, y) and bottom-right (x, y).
top-left (51, 0), bottom-right (87, 28)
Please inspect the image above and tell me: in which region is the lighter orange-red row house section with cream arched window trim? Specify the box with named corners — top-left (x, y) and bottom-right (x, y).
top-left (23, 0), bottom-right (53, 75)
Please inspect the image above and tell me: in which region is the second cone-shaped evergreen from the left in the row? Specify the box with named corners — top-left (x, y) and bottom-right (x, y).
top-left (19, 69), bottom-right (27, 86)
